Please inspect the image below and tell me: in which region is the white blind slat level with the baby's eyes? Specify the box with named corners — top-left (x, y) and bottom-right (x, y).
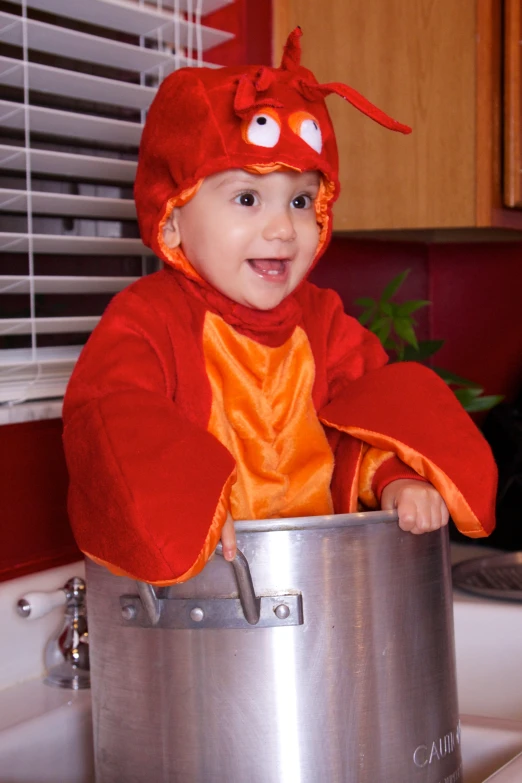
top-left (0, 188), bottom-right (136, 220)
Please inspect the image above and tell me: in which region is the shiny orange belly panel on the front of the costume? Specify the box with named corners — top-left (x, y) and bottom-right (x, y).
top-left (203, 312), bottom-right (333, 519)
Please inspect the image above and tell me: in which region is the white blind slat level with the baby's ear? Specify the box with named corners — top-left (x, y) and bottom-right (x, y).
top-left (0, 232), bottom-right (151, 254)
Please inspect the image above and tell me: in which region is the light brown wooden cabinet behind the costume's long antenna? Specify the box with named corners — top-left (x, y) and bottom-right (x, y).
top-left (273, 0), bottom-right (522, 231)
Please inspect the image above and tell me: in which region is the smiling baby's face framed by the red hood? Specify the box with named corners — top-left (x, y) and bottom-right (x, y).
top-left (164, 169), bottom-right (320, 310)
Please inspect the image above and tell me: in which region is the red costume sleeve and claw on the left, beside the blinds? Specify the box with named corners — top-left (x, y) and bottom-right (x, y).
top-left (63, 273), bottom-right (234, 584)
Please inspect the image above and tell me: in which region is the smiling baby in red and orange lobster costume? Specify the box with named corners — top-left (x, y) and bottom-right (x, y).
top-left (64, 30), bottom-right (496, 584)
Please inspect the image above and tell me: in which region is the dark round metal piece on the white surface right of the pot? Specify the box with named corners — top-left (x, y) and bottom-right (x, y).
top-left (452, 552), bottom-right (522, 601)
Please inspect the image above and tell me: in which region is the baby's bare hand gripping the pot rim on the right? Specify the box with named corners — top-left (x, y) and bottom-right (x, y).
top-left (381, 479), bottom-right (449, 534)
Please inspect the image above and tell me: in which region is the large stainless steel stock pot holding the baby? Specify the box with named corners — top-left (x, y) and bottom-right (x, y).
top-left (87, 512), bottom-right (462, 783)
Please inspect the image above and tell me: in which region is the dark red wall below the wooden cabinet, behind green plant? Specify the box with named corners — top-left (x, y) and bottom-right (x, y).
top-left (313, 237), bottom-right (522, 404)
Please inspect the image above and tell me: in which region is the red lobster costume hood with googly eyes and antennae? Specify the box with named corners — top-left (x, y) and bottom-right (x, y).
top-left (134, 28), bottom-right (411, 270)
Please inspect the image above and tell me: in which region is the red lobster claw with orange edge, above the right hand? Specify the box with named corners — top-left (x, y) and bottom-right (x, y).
top-left (320, 362), bottom-right (497, 538)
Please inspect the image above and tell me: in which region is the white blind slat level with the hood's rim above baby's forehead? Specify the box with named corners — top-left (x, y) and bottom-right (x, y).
top-left (0, 144), bottom-right (136, 184)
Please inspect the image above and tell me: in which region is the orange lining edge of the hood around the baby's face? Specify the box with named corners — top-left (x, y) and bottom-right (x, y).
top-left (158, 163), bottom-right (335, 282)
